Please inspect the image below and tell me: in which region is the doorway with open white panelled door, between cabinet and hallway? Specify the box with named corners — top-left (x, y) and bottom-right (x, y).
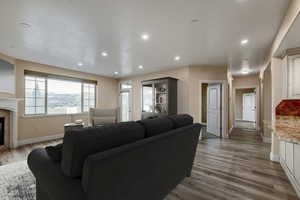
top-left (201, 82), bottom-right (224, 138)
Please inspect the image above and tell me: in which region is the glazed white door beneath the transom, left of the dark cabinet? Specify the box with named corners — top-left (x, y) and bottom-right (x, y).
top-left (120, 90), bottom-right (132, 122)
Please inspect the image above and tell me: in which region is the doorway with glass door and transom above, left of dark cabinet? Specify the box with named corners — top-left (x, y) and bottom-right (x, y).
top-left (119, 81), bottom-right (132, 122)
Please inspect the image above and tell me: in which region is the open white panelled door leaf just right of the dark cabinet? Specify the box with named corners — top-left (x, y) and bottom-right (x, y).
top-left (207, 84), bottom-right (221, 136)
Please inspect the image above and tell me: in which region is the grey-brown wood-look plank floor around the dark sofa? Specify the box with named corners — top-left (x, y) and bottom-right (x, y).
top-left (0, 129), bottom-right (298, 200)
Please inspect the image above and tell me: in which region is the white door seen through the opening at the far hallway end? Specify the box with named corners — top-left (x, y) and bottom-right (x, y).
top-left (243, 93), bottom-right (256, 122)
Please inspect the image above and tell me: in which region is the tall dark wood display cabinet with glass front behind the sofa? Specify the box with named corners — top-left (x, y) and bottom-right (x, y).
top-left (142, 77), bottom-right (178, 119)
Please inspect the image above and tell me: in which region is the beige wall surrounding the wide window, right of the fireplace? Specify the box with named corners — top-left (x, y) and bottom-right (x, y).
top-left (2, 60), bottom-right (118, 141)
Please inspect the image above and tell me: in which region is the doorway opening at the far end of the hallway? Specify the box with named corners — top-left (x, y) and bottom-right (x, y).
top-left (234, 88), bottom-right (257, 130)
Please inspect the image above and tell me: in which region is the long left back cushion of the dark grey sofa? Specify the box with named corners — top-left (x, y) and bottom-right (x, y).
top-left (61, 122), bottom-right (145, 178)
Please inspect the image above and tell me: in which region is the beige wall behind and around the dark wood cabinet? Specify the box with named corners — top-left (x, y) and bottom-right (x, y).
top-left (120, 67), bottom-right (227, 125)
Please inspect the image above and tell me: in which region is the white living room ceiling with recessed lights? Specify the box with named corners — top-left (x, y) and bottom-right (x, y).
top-left (0, 0), bottom-right (289, 77)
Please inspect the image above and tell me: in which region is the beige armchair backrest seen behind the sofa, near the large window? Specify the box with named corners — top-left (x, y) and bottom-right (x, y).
top-left (89, 108), bottom-right (117, 127)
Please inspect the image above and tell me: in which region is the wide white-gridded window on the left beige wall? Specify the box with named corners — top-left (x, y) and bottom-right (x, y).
top-left (25, 72), bottom-right (96, 115)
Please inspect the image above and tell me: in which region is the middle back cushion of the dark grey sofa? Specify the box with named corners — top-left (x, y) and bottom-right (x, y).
top-left (139, 117), bottom-right (173, 137)
